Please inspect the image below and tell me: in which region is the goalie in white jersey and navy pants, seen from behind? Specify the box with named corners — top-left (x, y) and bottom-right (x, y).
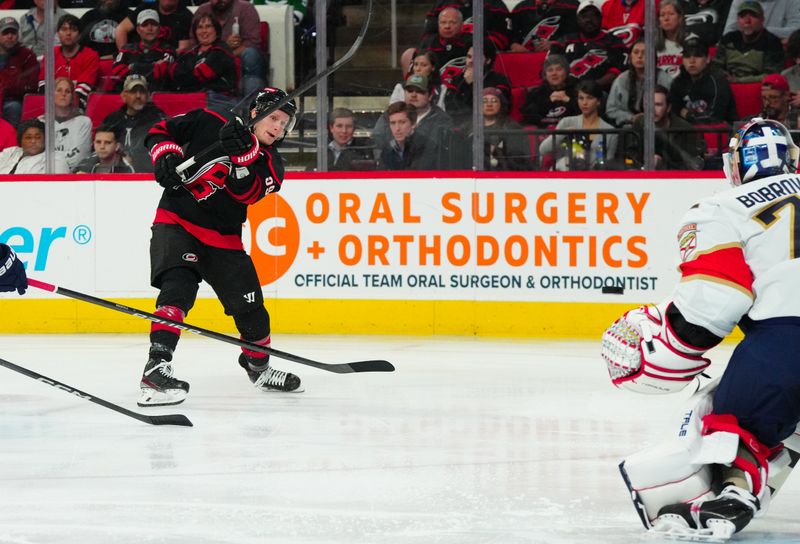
top-left (602, 118), bottom-right (800, 540)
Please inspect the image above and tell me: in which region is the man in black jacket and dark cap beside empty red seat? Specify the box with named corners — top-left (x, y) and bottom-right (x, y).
top-left (669, 39), bottom-right (737, 124)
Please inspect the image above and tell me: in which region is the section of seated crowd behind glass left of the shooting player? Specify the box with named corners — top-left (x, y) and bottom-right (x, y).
top-left (0, 0), bottom-right (267, 173)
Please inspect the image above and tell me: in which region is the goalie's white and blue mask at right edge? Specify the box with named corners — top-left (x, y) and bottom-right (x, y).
top-left (722, 117), bottom-right (800, 187)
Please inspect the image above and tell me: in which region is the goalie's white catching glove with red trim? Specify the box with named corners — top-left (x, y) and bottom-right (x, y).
top-left (600, 303), bottom-right (711, 394)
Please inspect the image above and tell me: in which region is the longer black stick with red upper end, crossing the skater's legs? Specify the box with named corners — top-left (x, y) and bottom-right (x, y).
top-left (28, 278), bottom-right (394, 374)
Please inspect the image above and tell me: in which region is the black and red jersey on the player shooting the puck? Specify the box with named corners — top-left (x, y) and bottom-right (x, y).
top-left (145, 109), bottom-right (284, 241)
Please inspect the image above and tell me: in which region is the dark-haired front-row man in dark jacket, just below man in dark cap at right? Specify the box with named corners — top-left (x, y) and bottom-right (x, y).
top-left (626, 85), bottom-right (705, 170)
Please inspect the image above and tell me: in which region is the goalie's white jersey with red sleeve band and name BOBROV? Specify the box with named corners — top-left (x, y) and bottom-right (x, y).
top-left (673, 174), bottom-right (800, 337)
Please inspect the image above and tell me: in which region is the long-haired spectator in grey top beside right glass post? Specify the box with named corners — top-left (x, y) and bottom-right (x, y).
top-left (606, 39), bottom-right (672, 127)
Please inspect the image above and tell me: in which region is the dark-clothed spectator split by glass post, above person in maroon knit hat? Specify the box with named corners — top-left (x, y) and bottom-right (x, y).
top-left (439, 40), bottom-right (511, 126)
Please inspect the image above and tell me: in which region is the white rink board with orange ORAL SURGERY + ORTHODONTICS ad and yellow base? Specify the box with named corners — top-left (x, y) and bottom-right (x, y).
top-left (0, 172), bottom-right (726, 338)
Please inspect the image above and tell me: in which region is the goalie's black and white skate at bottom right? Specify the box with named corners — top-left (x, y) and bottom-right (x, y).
top-left (653, 484), bottom-right (760, 542)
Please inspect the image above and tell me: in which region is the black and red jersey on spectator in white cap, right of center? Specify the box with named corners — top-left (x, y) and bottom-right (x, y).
top-left (550, 30), bottom-right (626, 81)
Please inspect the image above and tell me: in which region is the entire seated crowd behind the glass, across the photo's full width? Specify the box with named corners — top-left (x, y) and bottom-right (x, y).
top-left (0, 0), bottom-right (800, 172)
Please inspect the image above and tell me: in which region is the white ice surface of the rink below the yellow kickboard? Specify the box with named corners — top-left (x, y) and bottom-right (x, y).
top-left (0, 334), bottom-right (800, 544)
